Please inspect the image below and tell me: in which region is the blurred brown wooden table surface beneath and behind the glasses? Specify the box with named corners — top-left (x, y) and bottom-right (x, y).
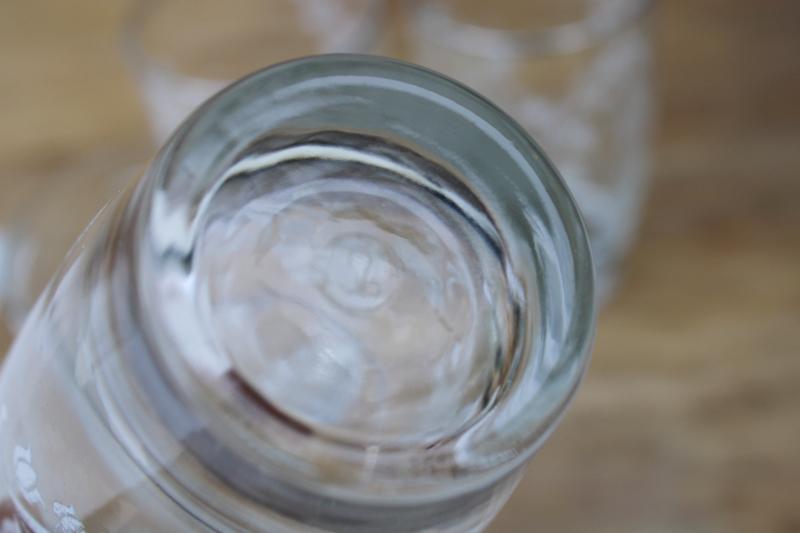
top-left (0, 0), bottom-right (800, 533)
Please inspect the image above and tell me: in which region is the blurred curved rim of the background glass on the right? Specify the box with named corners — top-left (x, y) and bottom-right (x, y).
top-left (412, 0), bottom-right (655, 59)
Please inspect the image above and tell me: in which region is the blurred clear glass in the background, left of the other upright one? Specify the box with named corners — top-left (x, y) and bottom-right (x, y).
top-left (123, 0), bottom-right (385, 144)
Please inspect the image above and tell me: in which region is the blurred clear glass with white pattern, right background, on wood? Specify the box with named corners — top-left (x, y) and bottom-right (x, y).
top-left (407, 0), bottom-right (652, 301)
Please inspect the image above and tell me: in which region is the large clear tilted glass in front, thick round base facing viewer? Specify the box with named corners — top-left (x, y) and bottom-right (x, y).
top-left (0, 55), bottom-right (594, 533)
